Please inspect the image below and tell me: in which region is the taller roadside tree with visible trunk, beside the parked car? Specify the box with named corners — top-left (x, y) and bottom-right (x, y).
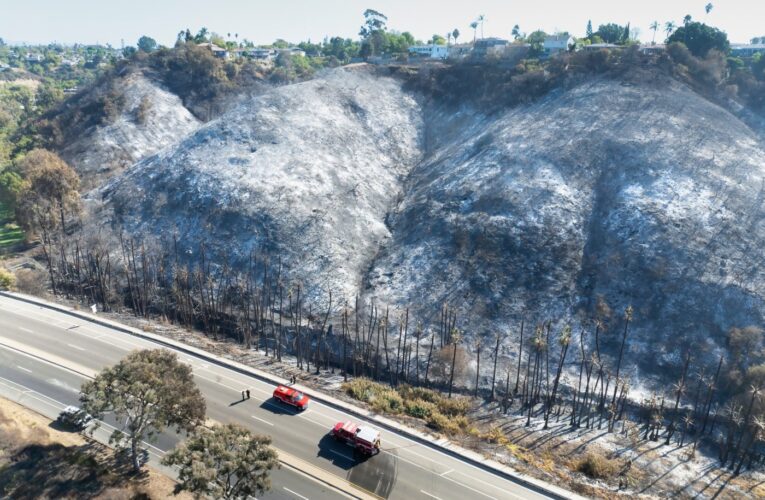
top-left (80, 349), bottom-right (205, 471)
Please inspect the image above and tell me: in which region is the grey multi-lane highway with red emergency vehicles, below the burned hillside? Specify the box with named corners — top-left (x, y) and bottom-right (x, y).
top-left (0, 297), bottom-right (547, 500)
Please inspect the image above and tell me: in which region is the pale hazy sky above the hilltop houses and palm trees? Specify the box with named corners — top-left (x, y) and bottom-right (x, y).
top-left (0, 0), bottom-right (765, 46)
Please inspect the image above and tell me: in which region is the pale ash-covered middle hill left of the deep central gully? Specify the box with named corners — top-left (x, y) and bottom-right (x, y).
top-left (102, 69), bottom-right (422, 303)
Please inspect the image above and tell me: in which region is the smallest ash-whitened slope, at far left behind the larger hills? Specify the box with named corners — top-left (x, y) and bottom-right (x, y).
top-left (61, 72), bottom-right (201, 188)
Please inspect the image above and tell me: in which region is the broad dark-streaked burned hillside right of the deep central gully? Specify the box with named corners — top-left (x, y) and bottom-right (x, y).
top-left (367, 78), bottom-right (765, 370)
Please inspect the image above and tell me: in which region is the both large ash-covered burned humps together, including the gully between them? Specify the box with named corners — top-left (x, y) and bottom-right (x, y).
top-left (89, 61), bottom-right (765, 372)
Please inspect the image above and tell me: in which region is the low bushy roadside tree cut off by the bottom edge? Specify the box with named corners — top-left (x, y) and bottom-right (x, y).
top-left (162, 424), bottom-right (279, 498)
